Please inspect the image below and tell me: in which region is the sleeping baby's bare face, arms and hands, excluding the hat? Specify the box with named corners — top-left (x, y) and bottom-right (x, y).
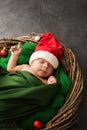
top-left (7, 43), bottom-right (57, 84)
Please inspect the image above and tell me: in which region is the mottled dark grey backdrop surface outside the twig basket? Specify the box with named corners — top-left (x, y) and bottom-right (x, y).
top-left (0, 0), bottom-right (87, 130)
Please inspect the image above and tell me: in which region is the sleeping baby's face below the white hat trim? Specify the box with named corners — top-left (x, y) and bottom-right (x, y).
top-left (31, 58), bottom-right (54, 78)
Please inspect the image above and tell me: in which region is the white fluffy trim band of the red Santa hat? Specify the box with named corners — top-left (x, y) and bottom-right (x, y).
top-left (29, 51), bottom-right (59, 69)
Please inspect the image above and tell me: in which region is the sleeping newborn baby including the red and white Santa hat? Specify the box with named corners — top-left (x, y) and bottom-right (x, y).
top-left (7, 32), bottom-right (63, 84)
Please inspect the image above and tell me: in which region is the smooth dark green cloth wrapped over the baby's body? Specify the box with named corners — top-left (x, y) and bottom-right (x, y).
top-left (0, 71), bottom-right (58, 120)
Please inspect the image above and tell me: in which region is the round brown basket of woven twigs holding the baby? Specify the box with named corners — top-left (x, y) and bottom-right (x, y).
top-left (0, 33), bottom-right (83, 130)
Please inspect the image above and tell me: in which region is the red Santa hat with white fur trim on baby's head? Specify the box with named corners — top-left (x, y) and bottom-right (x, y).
top-left (29, 32), bottom-right (63, 69)
